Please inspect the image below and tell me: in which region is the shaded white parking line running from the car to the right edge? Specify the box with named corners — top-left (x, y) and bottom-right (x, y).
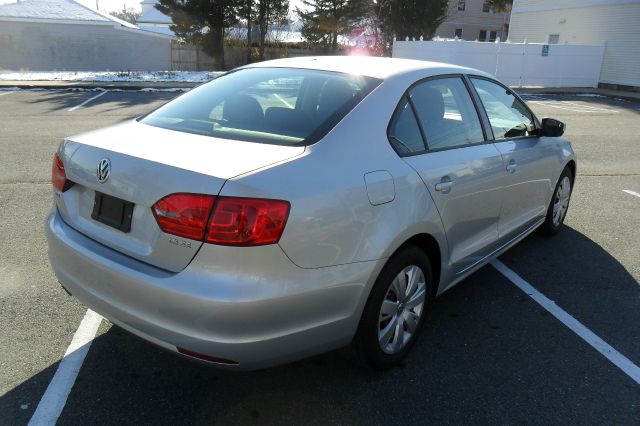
top-left (491, 260), bottom-right (640, 385)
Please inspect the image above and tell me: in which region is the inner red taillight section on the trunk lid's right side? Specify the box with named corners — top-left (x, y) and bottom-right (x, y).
top-left (151, 194), bottom-right (215, 240)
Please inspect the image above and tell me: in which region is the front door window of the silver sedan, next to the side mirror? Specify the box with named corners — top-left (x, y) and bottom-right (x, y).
top-left (471, 78), bottom-right (535, 140)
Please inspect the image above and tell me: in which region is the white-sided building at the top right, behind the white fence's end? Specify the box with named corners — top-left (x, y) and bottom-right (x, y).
top-left (509, 0), bottom-right (640, 88)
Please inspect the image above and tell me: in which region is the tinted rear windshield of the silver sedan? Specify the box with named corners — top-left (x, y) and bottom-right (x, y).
top-left (141, 68), bottom-right (380, 145)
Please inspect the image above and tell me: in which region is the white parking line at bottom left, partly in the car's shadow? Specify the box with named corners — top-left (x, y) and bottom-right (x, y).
top-left (29, 309), bottom-right (102, 426)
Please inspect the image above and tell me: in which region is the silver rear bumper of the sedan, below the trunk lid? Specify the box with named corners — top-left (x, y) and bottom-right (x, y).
top-left (46, 208), bottom-right (381, 370)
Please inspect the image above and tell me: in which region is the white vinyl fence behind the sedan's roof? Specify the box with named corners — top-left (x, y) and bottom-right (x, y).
top-left (393, 40), bottom-right (605, 87)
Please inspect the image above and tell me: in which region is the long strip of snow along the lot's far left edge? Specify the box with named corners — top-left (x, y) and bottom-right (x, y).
top-left (0, 71), bottom-right (222, 83)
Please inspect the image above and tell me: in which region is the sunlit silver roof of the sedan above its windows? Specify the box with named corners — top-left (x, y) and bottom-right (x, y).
top-left (243, 56), bottom-right (489, 79)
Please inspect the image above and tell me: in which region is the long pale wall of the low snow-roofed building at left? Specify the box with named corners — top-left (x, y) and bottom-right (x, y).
top-left (0, 21), bottom-right (171, 71)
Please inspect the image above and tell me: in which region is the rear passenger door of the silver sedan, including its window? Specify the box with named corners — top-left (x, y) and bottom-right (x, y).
top-left (396, 76), bottom-right (503, 273)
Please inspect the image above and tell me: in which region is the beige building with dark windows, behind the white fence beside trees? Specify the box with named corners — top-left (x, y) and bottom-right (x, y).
top-left (436, 0), bottom-right (509, 41)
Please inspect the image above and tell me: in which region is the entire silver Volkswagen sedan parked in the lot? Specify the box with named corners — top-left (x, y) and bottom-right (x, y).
top-left (46, 57), bottom-right (576, 369)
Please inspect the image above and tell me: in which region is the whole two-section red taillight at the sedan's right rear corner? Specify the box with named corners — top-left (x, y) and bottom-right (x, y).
top-left (151, 194), bottom-right (289, 246)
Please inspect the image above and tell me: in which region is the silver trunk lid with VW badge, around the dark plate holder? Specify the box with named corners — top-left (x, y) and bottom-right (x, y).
top-left (55, 122), bottom-right (304, 272)
